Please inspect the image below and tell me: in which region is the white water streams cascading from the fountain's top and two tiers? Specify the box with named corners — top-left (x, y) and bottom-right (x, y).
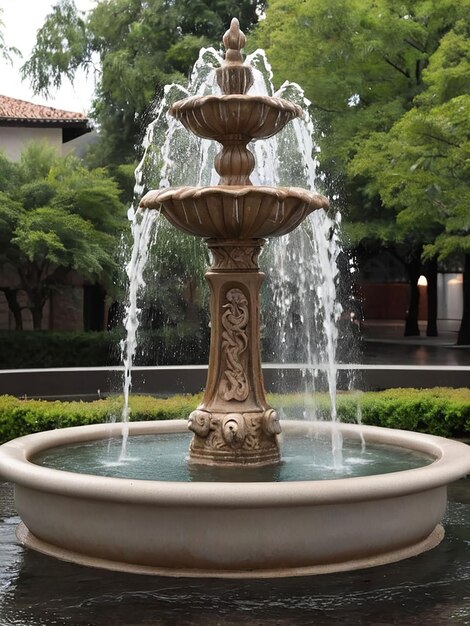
top-left (121, 48), bottom-right (342, 460)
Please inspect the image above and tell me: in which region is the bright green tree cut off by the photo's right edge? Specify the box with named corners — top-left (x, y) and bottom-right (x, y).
top-left (349, 21), bottom-right (470, 343)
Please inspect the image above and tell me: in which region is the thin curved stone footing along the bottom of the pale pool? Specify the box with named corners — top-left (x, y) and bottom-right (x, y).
top-left (16, 523), bottom-right (445, 579)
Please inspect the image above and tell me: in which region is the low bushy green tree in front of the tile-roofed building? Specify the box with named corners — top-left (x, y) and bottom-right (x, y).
top-left (0, 143), bottom-right (124, 330)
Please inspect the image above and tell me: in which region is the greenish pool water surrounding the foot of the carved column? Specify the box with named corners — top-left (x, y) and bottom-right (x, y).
top-left (33, 433), bottom-right (433, 482)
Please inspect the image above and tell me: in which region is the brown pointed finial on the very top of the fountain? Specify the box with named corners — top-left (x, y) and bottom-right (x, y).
top-left (217, 17), bottom-right (253, 95)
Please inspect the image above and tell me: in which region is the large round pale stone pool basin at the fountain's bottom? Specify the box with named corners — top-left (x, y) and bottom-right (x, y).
top-left (0, 420), bottom-right (470, 578)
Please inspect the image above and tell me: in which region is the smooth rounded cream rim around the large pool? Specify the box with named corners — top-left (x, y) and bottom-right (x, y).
top-left (0, 420), bottom-right (470, 508)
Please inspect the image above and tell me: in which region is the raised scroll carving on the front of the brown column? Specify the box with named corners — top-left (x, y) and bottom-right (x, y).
top-left (219, 288), bottom-right (249, 402)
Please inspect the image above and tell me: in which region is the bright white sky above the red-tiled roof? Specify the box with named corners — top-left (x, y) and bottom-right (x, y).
top-left (0, 0), bottom-right (95, 114)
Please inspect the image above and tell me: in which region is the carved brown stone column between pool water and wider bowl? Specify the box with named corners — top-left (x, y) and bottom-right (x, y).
top-left (189, 239), bottom-right (280, 465)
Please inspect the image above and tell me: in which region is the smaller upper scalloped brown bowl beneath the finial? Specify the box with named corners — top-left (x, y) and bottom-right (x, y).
top-left (170, 94), bottom-right (303, 143)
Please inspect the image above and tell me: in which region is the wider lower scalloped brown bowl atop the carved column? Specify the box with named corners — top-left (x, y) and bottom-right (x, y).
top-left (140, 185), bottom-right (329, 239)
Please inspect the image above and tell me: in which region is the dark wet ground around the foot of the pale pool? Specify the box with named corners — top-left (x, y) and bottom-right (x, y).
top-left (0, 479), bottom-right (470, 626)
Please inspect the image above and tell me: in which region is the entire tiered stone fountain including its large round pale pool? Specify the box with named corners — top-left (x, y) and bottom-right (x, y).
top-left (0, 20), bottom-right (470, 578)
